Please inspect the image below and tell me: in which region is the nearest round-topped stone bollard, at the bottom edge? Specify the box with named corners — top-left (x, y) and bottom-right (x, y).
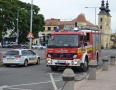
top-left (62, 68), bottom-right (75, 90)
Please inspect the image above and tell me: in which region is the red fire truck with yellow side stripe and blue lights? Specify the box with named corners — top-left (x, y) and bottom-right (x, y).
top-left (46, 27), bottom-right (101, 71)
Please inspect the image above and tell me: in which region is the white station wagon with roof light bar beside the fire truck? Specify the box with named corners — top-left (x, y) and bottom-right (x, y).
top-left (2, 49), bottom-right (40, 67)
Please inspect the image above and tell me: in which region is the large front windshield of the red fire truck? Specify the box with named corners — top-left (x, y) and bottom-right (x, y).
top-left (47, 34), bottom-right (78, 48)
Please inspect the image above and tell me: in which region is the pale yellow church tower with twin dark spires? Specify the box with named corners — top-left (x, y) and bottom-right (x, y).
top-left (98, 0), bottom-right (111, 48)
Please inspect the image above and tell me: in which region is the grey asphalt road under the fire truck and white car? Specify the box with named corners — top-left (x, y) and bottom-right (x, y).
top-left (0, 50), bottom-right (115, 90)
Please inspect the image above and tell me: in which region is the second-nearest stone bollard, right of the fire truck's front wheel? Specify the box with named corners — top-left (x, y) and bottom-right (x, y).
top-left (88, 60), bottom-right (97, 80)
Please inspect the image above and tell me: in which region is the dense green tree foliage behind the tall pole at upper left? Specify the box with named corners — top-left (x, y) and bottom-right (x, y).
top-left (0, 0), bottom-right (45, 43)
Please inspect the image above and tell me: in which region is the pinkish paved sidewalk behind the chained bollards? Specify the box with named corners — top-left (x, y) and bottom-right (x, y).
top-left (74, 66), bottom-right (116, 90)
